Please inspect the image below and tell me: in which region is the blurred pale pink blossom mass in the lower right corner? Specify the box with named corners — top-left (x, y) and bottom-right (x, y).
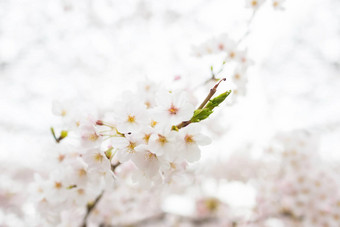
top-left (256, 131), bottom-right (340, 227)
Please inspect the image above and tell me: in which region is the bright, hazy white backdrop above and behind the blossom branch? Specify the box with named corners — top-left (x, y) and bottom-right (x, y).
top-left (0, 0), bottom-right (340, 222)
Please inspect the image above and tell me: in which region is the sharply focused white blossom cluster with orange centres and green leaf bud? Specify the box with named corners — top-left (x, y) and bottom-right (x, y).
top-left (32, 81), bottom-right (230, 225)
